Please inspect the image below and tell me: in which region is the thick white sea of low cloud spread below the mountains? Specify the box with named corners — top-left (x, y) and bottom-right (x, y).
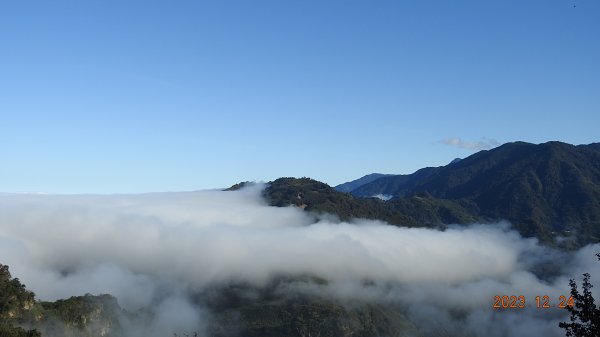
top-left (0, 186), bottom-right (600, 336)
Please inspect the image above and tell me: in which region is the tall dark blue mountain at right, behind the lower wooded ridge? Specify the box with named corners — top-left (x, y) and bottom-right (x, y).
top-left (351, 142), bottom-right (600, 244)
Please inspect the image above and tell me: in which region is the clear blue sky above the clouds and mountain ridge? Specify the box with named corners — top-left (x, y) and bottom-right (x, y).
top-left (0, 0), bottom-right (600, 193)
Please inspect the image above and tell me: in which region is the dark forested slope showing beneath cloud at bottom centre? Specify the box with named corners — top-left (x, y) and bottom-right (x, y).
top-left (203, 277), bottom-right (421, 337)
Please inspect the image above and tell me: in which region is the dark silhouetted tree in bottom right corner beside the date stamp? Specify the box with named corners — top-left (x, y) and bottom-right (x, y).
top-left (558, 253), bottom-right (600, 337)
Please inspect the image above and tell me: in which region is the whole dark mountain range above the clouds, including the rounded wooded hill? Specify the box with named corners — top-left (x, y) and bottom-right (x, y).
top-left (264, 142), bottom-right (600, 248)
